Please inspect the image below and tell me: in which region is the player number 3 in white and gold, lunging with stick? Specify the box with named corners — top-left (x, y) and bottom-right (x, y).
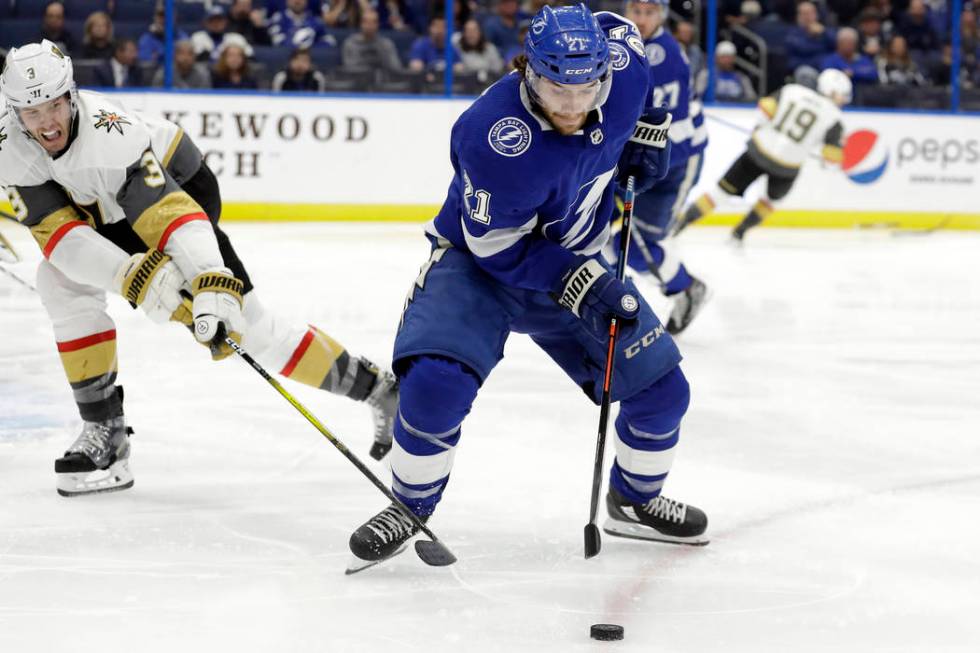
top-left (0, 41), bottom-right (398, 495)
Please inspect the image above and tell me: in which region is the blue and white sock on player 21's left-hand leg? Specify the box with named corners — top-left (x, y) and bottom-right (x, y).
top-left (390, 356), bottom-right (480, 517)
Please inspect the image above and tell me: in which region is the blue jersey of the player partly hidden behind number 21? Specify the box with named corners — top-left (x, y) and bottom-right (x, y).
top-left (643, 27), bottom-right (706, 168)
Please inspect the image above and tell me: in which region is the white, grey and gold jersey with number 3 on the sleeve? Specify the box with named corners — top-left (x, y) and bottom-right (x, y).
top-left (0, 91), bottom-right (222, 289)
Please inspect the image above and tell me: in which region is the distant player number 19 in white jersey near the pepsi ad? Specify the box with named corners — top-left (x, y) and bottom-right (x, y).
top-left (674, 68), bottom-right (851, 243)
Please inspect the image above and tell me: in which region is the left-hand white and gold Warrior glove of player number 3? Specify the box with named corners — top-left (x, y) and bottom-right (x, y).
top-left (114, 249), bottom-right (186, 324)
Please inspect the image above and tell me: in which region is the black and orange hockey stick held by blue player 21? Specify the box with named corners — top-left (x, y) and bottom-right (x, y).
top-left (585, 176), bottom-right (635, 559)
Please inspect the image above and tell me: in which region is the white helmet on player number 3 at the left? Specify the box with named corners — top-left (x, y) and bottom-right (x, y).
top-left (0, 39), bottom-right (78, 118)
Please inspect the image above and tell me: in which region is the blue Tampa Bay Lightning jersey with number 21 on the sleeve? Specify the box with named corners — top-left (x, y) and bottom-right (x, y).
top-left (426, 12), bottom-right (649, 291)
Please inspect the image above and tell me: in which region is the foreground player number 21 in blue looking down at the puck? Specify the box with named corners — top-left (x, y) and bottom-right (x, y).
top-left (350, 5), bottom-right (707, 567)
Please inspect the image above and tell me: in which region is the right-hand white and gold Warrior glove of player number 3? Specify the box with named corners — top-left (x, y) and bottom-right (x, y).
top-left (191, 268), bottom-right (245, 361)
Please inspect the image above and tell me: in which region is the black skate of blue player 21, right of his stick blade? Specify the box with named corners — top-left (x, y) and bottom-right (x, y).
top-left (602, 487), bottom-right (710, 545)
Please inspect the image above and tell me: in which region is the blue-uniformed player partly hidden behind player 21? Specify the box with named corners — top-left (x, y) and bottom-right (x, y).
top-left (606, 0), bottom-right (707, 334)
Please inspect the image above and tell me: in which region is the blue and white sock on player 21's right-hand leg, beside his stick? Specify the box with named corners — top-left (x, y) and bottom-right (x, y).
top-left (609, 367), bottom-right (690, 503)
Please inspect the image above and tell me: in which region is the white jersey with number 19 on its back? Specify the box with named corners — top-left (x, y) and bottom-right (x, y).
top-left (749, 84), bottom-right (843, 175)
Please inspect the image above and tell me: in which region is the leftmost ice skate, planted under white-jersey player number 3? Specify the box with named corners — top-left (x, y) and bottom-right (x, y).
top-left (54, 417), bottom-right (133, 497)
